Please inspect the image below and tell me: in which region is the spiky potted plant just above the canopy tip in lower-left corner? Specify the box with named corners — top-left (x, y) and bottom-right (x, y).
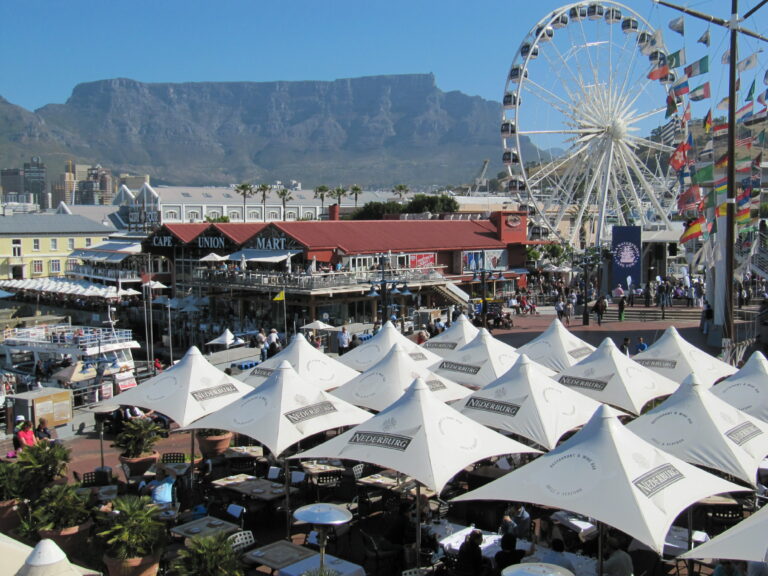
top-left (31, 484), bottom-right (93, 556)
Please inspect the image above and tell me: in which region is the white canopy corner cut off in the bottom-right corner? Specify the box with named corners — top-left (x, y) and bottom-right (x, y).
top-left (678, 506), bottom-right (768, 562)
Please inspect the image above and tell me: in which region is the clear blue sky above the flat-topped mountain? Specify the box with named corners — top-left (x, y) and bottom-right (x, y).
top-left (0, 0), bottom-right (768, 110)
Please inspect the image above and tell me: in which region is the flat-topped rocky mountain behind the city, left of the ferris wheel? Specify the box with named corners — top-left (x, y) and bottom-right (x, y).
top-left (0, 74), bottom-right (536, 187)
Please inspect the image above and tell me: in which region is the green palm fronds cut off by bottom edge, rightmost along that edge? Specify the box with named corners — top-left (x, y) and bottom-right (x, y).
top-left (173, 532), bottom-right (243, 576)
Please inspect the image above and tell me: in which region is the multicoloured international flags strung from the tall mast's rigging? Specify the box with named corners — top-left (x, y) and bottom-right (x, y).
top-left (644, 15), bottom-right (768, 243)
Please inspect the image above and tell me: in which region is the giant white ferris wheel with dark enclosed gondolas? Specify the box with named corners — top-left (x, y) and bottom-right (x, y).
top-left (501, 0), bottom-right (678, 246)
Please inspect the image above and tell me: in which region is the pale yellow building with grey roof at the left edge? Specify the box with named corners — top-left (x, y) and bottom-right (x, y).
top-left (0, 213), bottom-right (115, 279)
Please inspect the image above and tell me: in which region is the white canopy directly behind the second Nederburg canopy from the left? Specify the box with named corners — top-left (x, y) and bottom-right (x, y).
top-left (240, 334), bottom-right (359, 390)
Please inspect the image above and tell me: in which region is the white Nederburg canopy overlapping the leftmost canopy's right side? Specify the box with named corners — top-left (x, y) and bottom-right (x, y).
top-left (188, 361), bottom-right (371, 456)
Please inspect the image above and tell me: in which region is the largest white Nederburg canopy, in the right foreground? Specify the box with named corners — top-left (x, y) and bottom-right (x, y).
top-left (454, 405), bottom-right (744, 552)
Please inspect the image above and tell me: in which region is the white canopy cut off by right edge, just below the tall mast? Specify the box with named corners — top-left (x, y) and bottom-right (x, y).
top-left (712, 351), bottom-right (768, 422)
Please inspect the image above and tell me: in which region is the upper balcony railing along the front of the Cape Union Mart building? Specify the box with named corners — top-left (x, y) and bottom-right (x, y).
top-left (193, 268), bottom-right (445, 290)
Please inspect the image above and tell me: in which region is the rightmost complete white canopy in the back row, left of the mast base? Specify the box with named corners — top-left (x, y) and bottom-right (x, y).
top-left (633, 326), bottom-right (736, 386)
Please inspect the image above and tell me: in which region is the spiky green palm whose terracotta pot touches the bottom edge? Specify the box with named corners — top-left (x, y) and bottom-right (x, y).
top-left (98, 496), bottom-right (165, 576)
